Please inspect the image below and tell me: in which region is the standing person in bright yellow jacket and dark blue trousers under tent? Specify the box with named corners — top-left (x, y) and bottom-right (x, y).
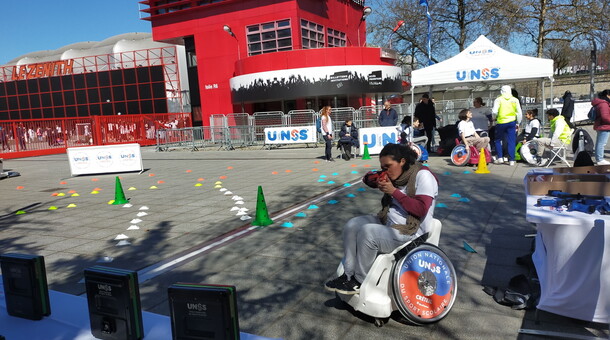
top-left (491, 85), bottom-right (523, 166)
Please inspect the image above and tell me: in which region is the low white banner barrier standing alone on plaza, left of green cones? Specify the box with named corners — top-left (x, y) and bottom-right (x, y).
top-left (67, 143), bottom-right (144, 176)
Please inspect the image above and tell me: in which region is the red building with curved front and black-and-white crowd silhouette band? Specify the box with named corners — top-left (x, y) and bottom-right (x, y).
top-left (141, 0), bottom-right (402, 125)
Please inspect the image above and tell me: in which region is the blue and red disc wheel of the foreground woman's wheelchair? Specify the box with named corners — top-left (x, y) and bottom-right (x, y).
top-left (391, 244), bottom-right (457, 325)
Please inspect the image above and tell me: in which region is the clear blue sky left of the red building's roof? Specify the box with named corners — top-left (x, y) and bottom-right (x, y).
top-left (0, 0), bottom-right (151, 65)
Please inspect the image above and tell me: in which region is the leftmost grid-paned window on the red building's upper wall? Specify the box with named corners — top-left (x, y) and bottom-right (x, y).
top-left (246, 20), bottom-right (292, 55)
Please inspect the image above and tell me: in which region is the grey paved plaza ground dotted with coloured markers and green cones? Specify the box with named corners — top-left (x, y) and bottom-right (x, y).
top-left (0, 147), bottom-right (608, 339)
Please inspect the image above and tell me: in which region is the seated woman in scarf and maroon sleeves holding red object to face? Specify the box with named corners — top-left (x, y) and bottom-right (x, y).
top-left (325, 144), bottom-right (438, 295)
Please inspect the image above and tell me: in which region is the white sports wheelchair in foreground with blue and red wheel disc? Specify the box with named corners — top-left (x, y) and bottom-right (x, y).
top-left (337, 219), bottom-right (457, 327)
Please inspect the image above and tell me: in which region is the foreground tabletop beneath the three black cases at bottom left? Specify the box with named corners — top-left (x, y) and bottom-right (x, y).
top-left (0, 276), bottom-right (278, 340)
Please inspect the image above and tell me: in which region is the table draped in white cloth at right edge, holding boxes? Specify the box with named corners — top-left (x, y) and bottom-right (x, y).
top-left (526, 196), bottom-right (610, 323)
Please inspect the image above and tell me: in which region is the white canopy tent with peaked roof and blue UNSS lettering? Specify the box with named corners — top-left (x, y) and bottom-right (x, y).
top-left (411, 35), bottom-right (554, 118)
